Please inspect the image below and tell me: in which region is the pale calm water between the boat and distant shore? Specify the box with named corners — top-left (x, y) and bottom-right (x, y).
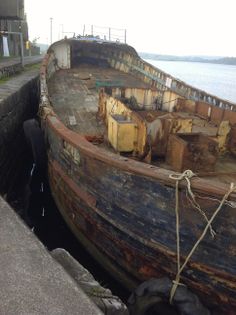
top-left (146, 59), bottom-right (236, 103)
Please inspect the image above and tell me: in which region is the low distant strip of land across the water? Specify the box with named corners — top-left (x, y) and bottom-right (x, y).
top-left (139, 52), bottom-right (236, 66)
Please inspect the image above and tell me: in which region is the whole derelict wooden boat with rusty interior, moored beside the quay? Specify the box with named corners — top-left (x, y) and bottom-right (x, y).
top-left (40, 38), bottom-right (236, 314)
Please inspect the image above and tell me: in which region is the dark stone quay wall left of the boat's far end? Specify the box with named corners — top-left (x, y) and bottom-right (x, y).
top-left (0, 70), bottom-right (39, 195)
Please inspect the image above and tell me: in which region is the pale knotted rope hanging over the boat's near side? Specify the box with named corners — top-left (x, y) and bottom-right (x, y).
top-left (169, 170), bottom-right (236, 303)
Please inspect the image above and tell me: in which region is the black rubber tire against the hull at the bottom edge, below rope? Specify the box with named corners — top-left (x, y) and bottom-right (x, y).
top-left (128, 278), bottom-right (210, 315)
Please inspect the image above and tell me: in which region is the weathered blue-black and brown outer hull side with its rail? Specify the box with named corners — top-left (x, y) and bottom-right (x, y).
top-left (41, 39), bottom-right (236, 315)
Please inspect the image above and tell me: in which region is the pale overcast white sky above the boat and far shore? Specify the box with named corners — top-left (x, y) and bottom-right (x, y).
top-left (25, 0), bottom-right (236, 57)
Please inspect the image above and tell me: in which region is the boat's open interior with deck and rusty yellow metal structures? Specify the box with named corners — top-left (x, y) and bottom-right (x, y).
top-left (48, 63), bottom-right (236, 183)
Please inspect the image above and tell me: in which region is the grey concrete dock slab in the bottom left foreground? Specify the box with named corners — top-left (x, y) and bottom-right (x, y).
top-left (0, 197), bottom-right (102, 315)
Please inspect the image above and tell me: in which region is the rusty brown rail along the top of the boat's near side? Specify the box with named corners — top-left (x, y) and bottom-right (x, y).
top-left (46, 113), bottom-right (236, 200)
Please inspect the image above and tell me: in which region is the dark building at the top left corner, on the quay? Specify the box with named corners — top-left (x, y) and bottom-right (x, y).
top-left (0, 0), bottom-right (28, 56)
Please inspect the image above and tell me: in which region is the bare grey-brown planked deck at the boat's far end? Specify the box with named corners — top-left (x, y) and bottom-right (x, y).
top-left (49, 64), bottom-right (150, 136)
